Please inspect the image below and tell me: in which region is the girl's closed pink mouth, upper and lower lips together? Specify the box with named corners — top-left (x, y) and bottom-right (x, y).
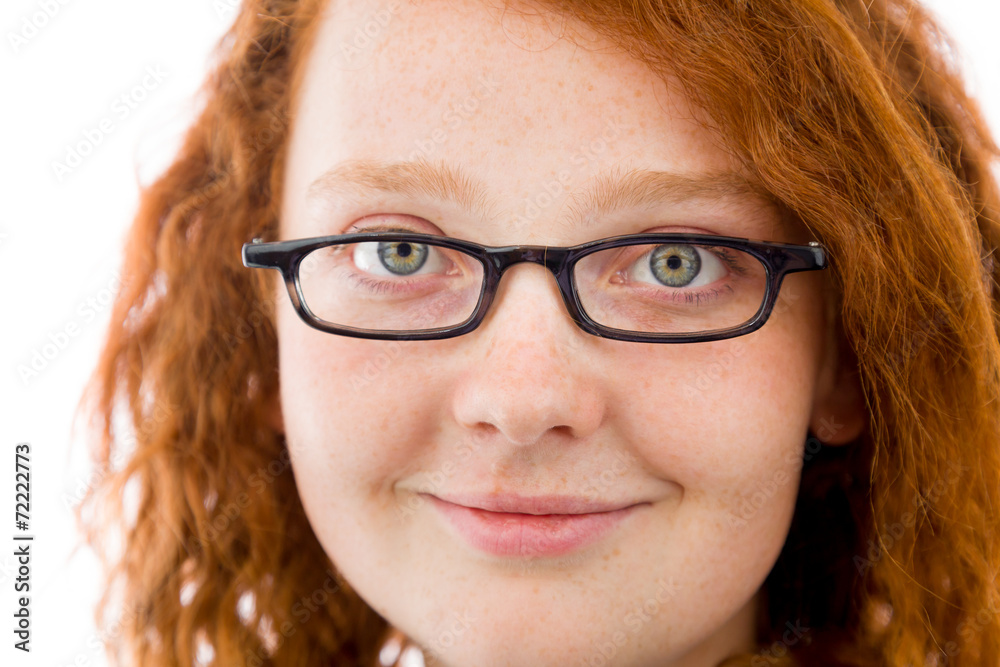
top-left (427, 495), bottom-right (645, 558)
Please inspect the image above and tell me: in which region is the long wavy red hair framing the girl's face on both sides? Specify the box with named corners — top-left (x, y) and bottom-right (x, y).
top-left (78, 0), bottom-right (1000, 667)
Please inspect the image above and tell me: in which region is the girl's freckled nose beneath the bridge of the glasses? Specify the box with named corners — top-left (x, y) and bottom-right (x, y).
top-left (453, 264), bottom-right (607, 446)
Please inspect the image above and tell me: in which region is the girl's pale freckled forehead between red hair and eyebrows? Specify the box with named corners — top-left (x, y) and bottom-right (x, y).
top-left (283, 0), bottom-right (796, 244)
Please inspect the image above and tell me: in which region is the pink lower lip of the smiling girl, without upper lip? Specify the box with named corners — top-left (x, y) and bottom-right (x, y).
top-left (428, 496), bottom-right (638, 558)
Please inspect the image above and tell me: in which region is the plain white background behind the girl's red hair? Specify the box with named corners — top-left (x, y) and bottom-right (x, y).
top-left (0, 0), bottom-right (1000, 667)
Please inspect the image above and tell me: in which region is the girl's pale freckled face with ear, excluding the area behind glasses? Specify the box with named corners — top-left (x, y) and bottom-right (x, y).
top-left (277, 0), bottom-right (861, 665)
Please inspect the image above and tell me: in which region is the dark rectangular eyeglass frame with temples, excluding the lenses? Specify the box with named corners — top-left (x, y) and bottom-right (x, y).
top-left (242, 231), bottom-right (828, 343)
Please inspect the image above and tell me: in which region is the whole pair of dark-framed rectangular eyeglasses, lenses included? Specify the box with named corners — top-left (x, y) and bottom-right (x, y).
top-left (243, 231), bottom-right (827, 343)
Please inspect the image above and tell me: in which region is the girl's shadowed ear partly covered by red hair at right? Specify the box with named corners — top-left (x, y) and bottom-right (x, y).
top-left (809, 318), bottom-right (868, 445)
